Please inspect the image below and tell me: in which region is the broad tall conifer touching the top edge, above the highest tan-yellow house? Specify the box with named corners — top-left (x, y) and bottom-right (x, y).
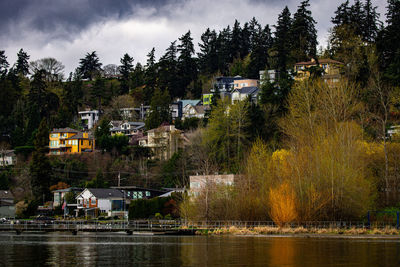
top-left (290, 0), bottom-right (318, 63)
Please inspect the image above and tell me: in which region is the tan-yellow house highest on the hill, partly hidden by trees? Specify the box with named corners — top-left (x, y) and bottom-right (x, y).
top-left (294, 58), bottom-right (344, 84)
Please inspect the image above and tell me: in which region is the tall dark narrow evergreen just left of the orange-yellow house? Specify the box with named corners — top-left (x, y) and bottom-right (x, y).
top-left (29, 119), bottom-right (52, 200)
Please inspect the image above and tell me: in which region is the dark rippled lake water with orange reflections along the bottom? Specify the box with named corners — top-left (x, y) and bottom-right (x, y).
top-left (0, 233), bottom-right (400, 266)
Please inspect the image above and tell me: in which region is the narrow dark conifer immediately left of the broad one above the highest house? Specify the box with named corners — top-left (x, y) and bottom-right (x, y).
top-left (273, 6), bottom-right (292, 72)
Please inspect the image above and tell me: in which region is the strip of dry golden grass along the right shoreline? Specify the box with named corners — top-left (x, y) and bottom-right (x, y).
top-left (196, 226), bottom-right (400, 235)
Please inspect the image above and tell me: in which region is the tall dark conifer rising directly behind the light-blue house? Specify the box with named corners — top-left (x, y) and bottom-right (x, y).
top-left (178, 31), bottom-right (201, 97)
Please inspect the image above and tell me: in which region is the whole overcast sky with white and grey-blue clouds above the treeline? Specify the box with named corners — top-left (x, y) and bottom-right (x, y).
top-left (0, 0), bottom-right (386, 76)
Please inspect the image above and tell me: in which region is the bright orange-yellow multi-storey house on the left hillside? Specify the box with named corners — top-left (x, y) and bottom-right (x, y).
top-left (49, 128), bottom-right (95, 155)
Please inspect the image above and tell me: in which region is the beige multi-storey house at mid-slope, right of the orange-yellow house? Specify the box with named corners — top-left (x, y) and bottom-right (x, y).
top-left (139, 125), bottom-right (182, 160)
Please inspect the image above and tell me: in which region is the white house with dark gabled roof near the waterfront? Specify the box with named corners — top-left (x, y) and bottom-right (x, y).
top-left (76, 188), bottom-right (127, 217)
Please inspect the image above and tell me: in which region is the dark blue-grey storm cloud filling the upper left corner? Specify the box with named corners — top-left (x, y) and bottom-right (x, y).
top-left (0, 0), bottom-right (175, 36)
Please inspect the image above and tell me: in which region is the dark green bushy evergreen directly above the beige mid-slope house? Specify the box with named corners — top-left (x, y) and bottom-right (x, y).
top-left (146, 88), bottom-right (171, 130)
